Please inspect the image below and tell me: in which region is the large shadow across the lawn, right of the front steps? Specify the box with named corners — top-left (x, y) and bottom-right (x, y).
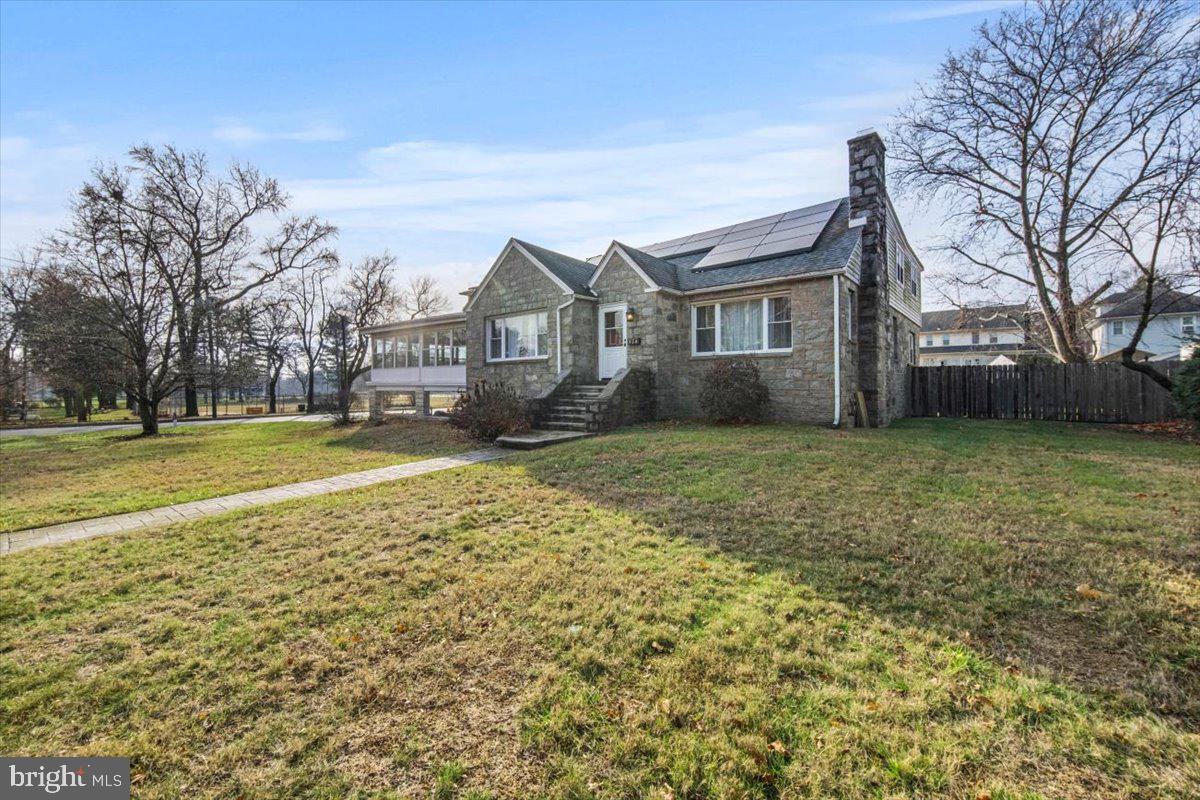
top-left (524, 420), bottom-right (1200, 730)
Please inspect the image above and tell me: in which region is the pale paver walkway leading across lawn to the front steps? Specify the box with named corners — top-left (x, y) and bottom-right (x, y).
top-left (0, 447), bottom-right (512, 555)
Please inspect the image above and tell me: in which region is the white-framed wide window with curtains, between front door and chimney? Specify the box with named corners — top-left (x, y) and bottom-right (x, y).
top-left (691, 295), bottom-right (792, 355)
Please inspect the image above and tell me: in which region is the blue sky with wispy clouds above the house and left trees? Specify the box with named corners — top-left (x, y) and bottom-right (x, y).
top-left (0, 1), bottom-right (1004, 299)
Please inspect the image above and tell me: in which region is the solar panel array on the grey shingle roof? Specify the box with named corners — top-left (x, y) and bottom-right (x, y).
top-left (640, 200), bottom-right (841, 270)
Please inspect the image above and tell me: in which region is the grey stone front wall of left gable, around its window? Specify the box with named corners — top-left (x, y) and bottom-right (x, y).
top-left (467, 247), bottom-right (595, 397)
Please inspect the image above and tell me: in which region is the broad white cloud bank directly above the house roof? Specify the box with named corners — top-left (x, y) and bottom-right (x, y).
top-left (288, 125), bottom-right (846, 255)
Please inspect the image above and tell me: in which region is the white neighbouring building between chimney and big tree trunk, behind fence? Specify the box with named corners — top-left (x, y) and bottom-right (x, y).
top-left (920, 305), bottom-right (1039, 367)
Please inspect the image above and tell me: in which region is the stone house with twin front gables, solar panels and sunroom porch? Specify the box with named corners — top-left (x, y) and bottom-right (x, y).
top-left (367, 131), bottom-right (923, 431)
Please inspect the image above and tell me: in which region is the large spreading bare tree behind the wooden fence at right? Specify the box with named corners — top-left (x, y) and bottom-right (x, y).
top-left (893, 0), bottom-right (1200, 362)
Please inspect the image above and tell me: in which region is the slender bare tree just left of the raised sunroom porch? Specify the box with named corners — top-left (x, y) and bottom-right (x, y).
top-left (322, 253), bottom-right (400, 422)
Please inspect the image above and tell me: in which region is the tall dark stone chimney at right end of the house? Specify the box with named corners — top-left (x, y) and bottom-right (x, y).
top-left (846, 128), bottom-right (890, 425)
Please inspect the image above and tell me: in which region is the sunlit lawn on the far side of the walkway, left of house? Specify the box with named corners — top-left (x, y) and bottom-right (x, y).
top-left (0, 420), bottom-right (476, 530)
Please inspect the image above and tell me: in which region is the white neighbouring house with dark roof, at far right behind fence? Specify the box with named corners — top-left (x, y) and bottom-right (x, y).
top-left (1090, 288), bottom-right (1200, 361)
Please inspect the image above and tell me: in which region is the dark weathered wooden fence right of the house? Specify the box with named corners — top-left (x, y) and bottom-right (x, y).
top-left (908, 362), bottom-right (1178, 422)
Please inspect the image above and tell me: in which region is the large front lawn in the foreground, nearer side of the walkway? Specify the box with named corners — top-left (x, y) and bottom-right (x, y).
top-left (0, 421), bottom-right (1200, 800)
